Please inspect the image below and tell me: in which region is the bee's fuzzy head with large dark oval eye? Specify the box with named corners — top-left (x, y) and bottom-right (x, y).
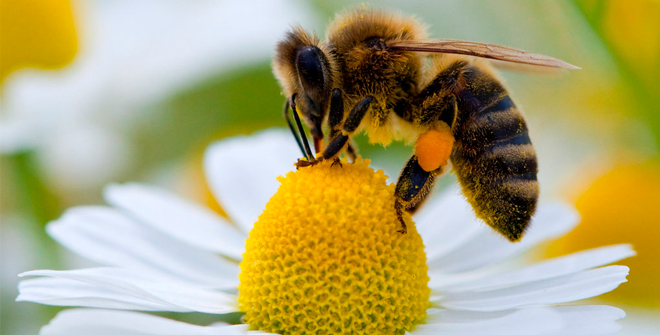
top-left (273, 27), bottom-right (334, 138)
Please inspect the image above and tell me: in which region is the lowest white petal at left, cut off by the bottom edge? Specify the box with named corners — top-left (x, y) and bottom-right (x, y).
top-left (39, 309), bottom-right (278, 335)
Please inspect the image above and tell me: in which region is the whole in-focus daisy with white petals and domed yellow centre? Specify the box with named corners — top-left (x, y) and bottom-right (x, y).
top-left (17, 130), bottom-right (634, 335)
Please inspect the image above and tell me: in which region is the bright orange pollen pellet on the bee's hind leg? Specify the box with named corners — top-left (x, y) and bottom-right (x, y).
top-left (415, 123), bottom-right (454, 172)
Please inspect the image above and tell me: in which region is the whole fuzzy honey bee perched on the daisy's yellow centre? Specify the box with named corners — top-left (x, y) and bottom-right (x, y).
top-left (273, 9), bottom-right (577, 242)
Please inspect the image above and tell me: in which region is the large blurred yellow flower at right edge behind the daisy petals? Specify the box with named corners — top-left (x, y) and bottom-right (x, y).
top-left (548, 162), bottom-right (660, 307)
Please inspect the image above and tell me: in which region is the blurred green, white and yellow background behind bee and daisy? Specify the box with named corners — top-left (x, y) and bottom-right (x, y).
top-left (0, 0), bottom-right (660, 335)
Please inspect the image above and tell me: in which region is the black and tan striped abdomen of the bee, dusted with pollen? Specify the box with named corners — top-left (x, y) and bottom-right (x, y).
top-left (451, 67), bottom-right (539, 241)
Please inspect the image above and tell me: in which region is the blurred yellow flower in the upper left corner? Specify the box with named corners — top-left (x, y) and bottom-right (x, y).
top-left (0, 0), bottom-right (78, 84)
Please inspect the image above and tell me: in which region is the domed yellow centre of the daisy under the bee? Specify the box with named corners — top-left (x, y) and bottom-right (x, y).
top-left (238, 160), bottom-right (430, 334)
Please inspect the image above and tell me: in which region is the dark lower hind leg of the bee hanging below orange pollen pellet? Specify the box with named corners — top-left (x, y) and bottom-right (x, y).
top-left (394, 155), bottom-right (442, 234)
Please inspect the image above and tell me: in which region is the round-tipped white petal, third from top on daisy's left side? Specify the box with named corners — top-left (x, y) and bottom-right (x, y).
top-left (46, 207), bottom-right (239, 288)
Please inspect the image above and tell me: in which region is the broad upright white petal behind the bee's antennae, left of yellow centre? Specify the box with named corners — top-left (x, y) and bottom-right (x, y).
top-left (204, 129), bottom-right (301, 233)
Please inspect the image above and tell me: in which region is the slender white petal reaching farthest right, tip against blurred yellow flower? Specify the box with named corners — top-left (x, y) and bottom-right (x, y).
top-left (431, 245), bottom-right (635, 293)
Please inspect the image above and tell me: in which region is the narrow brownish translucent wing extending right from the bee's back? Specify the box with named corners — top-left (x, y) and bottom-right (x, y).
top-left (387, 39), bottom-right (579, 70)
